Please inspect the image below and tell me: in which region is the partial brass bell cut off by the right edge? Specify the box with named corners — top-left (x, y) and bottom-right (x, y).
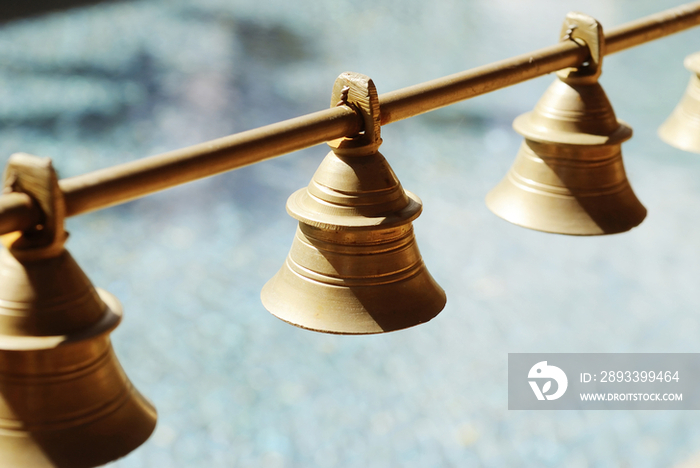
top-left (659, 52), bottom-right (700, 153)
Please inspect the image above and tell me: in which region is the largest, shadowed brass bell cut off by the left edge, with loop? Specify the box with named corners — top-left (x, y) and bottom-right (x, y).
top-left (0, 155), bottom-right (156, 468)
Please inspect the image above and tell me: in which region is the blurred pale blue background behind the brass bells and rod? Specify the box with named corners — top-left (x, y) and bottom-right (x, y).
top-left (0, 0), bottom-right (700, 468)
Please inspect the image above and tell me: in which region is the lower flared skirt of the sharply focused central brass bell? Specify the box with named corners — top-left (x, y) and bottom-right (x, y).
top-left (262, 219), bottom-right (445, 334)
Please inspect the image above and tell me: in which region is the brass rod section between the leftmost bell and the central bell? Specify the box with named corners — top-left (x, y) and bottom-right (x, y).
top-left (59, 107), bottom-right (362, 216)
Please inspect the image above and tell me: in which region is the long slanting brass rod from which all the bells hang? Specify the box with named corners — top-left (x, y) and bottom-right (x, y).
top-left (0, 1), bottom-right (700, 234)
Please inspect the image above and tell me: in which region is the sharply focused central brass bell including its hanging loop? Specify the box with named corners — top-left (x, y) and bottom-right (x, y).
top-left (261, 73), bottom-right (446, 334)
